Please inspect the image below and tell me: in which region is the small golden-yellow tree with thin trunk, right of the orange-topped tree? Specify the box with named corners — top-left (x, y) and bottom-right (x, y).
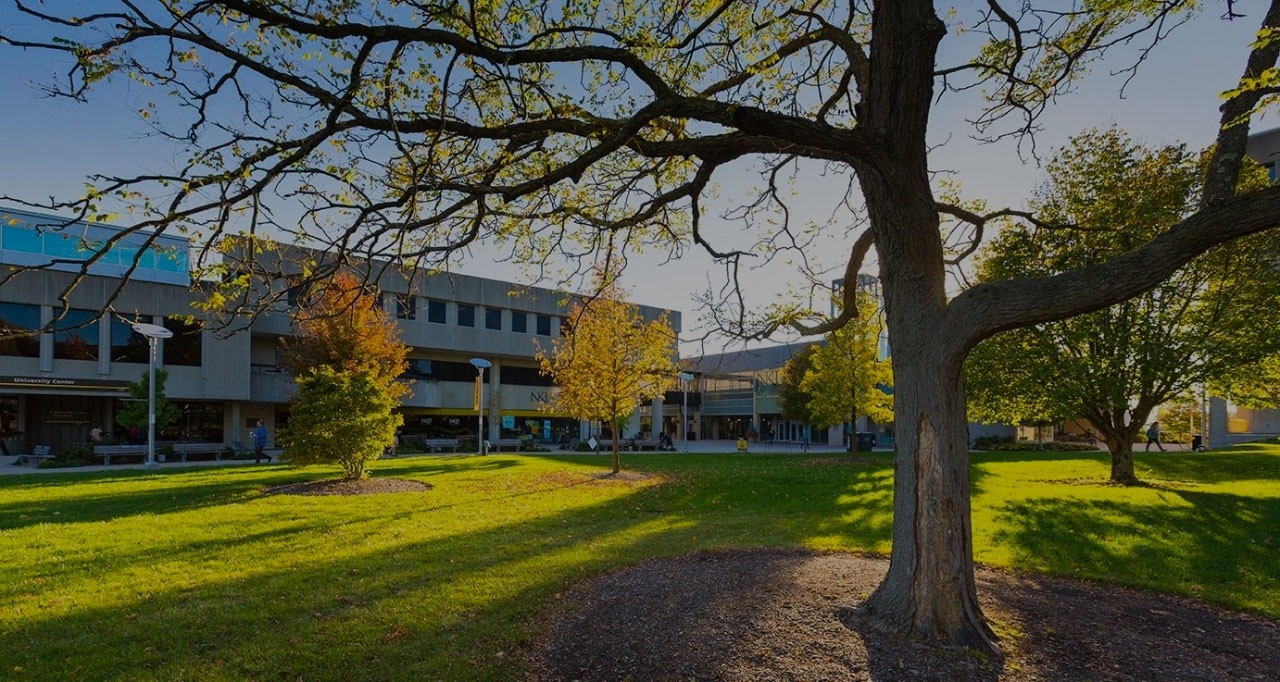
top-left (538, 273), bottom-right (680, 473)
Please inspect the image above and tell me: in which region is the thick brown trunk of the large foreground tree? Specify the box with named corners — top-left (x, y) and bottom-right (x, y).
top-left (854, 3), bottom-right (1000, 655)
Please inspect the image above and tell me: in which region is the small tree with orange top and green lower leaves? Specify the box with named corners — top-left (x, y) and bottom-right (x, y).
top-left (280, 274), bottom-right (408, 480)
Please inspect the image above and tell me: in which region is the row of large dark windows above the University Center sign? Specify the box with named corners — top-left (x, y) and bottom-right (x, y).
top-left (0, 303), bottom-right (201, 366)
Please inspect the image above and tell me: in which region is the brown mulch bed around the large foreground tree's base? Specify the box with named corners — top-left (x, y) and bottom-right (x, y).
top-left (526, 550), bottom-right (1280, 682)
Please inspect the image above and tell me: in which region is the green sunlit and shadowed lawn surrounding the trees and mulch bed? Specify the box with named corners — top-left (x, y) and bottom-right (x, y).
top-left (0, 441), bottom-right (1280, 681)
